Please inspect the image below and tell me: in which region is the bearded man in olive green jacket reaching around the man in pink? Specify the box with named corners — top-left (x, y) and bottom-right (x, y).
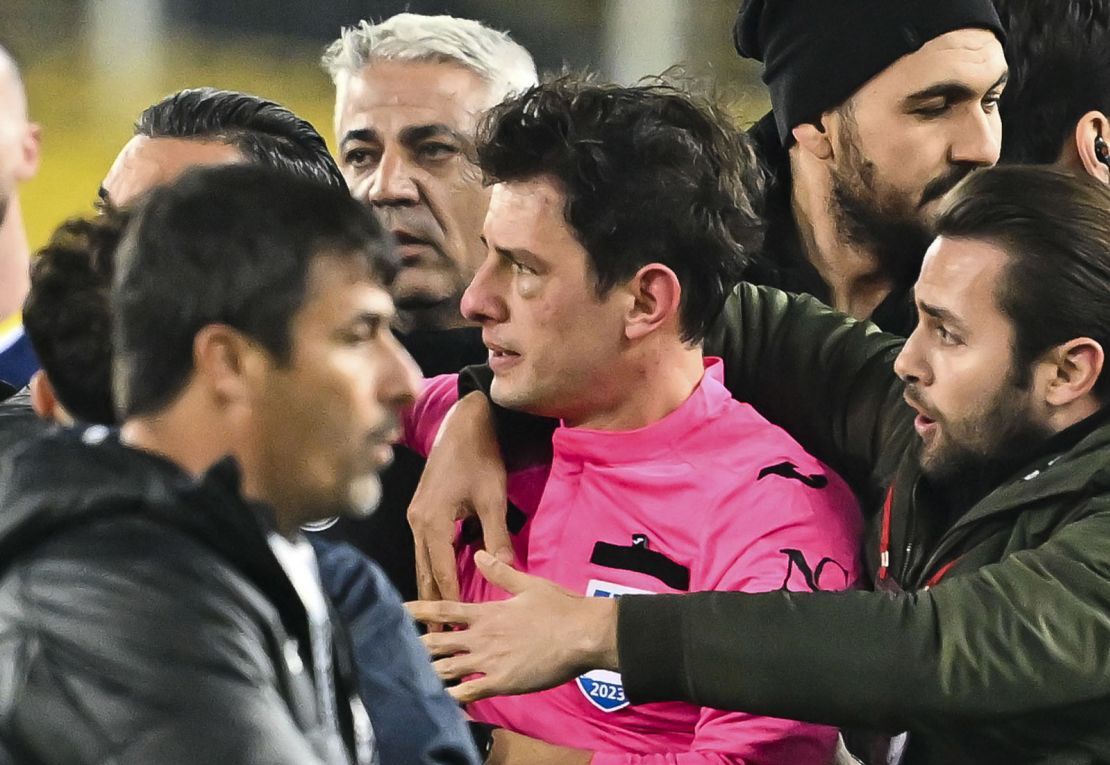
top-left (413, 162), bottom-right (1110, 765)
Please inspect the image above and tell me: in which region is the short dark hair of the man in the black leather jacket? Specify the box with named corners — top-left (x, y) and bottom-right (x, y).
top-left (112, 164), bottom-right (398, 419)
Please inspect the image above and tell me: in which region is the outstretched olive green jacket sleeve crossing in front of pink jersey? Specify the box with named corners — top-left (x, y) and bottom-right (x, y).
top-left (617, 519), bottom-right (1110, 729)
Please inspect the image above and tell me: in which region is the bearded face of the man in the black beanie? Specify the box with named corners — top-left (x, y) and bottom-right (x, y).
top-left (828, 29), bottom-right (1007, 282)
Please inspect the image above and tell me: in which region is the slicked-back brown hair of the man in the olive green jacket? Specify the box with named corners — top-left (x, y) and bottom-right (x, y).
top-left (936, 165), bottom-right (1110, 402)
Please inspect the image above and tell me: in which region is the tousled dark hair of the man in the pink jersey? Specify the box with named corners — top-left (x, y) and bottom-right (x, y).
top-left (477, 74), bottom-right (764, 342)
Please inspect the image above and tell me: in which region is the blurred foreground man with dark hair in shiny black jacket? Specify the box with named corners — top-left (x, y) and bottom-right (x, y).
top-left (0, 167), bottom-right (416, 764)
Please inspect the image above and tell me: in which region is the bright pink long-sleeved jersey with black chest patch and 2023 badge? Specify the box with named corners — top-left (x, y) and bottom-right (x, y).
top-left (405, 359), bottom-right (862, 765)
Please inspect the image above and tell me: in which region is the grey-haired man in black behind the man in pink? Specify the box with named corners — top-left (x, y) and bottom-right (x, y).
top-left (323, 13), bottom-right (536, 600)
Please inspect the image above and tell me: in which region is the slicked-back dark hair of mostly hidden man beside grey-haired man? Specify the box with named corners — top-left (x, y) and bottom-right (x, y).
top-left (135, 88), bottom-right (347, 191)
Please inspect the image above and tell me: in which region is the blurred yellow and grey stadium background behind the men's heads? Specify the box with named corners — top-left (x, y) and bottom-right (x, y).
top-left (10, 0), bottom-right (767, 248)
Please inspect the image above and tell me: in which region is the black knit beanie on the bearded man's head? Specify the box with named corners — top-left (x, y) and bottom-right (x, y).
top-left (733, 0), bottom-right (1005, 145)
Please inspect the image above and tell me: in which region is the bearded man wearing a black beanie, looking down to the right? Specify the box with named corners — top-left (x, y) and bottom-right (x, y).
top-left (734, 0), bottom-right (1007, 335)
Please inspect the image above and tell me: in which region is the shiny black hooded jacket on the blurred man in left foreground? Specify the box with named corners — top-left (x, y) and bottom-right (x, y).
top-left (0, 426), bottom-right (372, 765)
